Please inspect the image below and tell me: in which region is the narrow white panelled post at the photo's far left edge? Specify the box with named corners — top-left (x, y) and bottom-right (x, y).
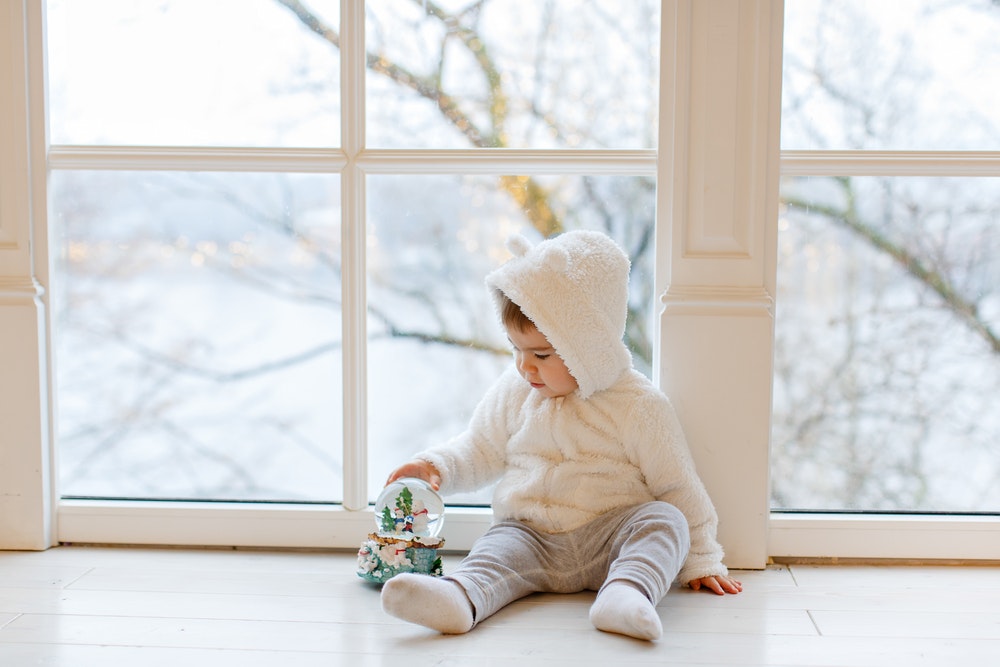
top-left (0, 0), bottom-right (54, 549)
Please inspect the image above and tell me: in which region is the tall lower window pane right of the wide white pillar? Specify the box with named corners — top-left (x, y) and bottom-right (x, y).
top-left (772, 178), bottom-right (1000, 512)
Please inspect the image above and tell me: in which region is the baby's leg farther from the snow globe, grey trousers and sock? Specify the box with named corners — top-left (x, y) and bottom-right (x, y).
top-left (590, 502), bottom-right (690, 639)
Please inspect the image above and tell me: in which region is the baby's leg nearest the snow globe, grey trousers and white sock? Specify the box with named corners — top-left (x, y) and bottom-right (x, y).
top-left (382, 522), bottom-right (548, 634)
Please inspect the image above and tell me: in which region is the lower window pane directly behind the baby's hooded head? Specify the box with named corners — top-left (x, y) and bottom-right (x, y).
top-left (368, 176), bottom-right (655, 502)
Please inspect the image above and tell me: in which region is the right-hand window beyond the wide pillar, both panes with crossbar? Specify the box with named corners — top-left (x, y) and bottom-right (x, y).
top-left (772, 0), bottom-right (1000, 513)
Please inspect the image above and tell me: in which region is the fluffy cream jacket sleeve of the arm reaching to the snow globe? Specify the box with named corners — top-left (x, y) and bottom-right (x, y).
top-left (415, 369), bottom-right (528, 495)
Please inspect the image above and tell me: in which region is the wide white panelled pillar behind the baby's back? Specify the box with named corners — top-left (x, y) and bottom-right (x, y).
top-left (657, 0), bottom-right (783, 568)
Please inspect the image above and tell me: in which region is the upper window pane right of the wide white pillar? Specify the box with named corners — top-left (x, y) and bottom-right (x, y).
top-left (781, 0), bottom-right (1000, 150)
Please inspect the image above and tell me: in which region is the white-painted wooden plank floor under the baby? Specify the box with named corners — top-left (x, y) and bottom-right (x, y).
top-left (0, 547), bottom-right (1000, 667)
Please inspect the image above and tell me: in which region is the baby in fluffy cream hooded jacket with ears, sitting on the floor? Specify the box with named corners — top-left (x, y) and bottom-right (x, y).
top-left (382, 231), bottom-right (742, 640)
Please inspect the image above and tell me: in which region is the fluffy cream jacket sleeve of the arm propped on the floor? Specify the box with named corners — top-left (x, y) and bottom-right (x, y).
top-left (626, 392), bottom-right (729, 584)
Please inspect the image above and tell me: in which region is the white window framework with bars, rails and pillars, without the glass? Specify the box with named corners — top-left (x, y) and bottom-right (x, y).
top-left (0, 0), bottom-right (1000, 567)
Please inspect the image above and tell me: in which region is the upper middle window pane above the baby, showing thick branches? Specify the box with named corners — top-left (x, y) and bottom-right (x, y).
top-left (367, 0), bottom-right (660, 148)
